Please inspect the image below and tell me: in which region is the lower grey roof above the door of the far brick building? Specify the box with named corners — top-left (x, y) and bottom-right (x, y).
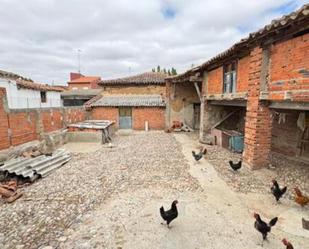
top-left (89, 95), bottom-right (165, 107)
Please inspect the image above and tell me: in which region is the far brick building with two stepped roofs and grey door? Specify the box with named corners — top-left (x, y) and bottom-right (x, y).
top-left (87, 72), bottom-right (166, 130)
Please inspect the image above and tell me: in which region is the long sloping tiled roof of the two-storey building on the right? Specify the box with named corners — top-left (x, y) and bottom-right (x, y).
top-left (169, 4), bottom-right (309, 79)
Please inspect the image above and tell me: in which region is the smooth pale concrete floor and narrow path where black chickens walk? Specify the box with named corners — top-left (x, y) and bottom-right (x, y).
top-left (60, 134), bottom-right (309, 249)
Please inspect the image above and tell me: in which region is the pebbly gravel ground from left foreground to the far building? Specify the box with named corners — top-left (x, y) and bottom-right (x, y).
top-left (0, 132), bottom-right (200, 248)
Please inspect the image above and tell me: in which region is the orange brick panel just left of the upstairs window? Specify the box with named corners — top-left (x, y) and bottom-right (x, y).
top-left (207, 67), bottom-right (223, 94)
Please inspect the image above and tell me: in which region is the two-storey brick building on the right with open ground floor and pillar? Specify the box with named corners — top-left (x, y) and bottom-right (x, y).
top-left (167, 4), bottom-right (309, 169)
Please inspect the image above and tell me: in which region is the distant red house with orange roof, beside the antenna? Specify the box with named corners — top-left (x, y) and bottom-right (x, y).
top-left (68, 73), bottom-right (101, 90)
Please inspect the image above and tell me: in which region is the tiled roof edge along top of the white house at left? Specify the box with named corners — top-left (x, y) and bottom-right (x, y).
top-left (0, 70), bottom-right (63, 92)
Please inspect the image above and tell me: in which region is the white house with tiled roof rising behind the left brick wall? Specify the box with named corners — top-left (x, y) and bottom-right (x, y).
top-left (0, 70), bottom-right (63, 109)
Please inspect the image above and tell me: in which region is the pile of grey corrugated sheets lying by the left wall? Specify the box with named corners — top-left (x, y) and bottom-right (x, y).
top-left (0, 149), bottom-right (71, 179)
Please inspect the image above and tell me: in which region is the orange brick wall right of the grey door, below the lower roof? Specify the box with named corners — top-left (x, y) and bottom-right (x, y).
top-left (132, 107), bottom-right (165, 130)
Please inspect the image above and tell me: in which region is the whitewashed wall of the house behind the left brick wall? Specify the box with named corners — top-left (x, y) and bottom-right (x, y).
top-left (0, 78), bottom-right (62, 109)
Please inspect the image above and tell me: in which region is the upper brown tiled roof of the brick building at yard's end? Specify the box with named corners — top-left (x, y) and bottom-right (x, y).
top-left (99, 72), bottom-right (167, 85)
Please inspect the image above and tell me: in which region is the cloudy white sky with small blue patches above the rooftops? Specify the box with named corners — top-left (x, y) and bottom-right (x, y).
top-left (0, 0), bottom-right (307, 84)
